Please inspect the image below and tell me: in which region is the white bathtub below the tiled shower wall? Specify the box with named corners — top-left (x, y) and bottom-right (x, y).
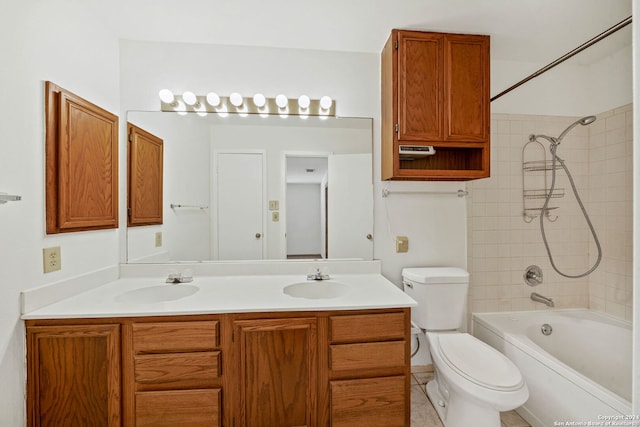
top-left (473, 309), bottom-right (638, 427)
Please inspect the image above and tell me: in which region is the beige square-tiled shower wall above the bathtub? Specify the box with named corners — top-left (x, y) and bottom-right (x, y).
top-left (468, 105), bottom-right (632, 320)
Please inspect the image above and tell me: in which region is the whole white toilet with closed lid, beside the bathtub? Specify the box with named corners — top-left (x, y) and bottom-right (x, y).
top-left (402, 267), bottom-right (529, 427)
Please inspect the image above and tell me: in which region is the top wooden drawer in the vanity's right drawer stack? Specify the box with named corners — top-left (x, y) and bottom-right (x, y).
top-left (329, 313), bottom-right (405, 343)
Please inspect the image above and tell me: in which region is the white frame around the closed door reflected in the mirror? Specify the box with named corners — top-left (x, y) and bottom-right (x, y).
top-left (209, 148), bottom-right (268, 261)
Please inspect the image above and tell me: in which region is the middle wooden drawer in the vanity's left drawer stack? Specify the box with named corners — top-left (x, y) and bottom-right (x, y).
top-left (134, 351), bottom-right (220, 389)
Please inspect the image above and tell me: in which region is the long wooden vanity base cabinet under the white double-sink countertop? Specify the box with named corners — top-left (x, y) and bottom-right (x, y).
top-left (27, 308), bottom-right (411, 427)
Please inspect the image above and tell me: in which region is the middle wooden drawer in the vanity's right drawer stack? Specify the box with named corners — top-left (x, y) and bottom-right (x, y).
top-left (330, 341), bottom-right (405, 371)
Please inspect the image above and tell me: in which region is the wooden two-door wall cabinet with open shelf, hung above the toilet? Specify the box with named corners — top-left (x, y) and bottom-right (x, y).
top-left (382, 30), bottom-right (490, 180)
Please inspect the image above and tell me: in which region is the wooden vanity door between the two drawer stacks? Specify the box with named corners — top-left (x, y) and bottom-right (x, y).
top-left (236, 319), bottom-right (317, 427)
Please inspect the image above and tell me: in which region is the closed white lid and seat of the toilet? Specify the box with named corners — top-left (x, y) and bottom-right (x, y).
top-left (429, 333), bottom-right (524, 392)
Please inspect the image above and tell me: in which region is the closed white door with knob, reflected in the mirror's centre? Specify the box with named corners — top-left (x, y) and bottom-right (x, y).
top-left (212, 153), bottom-right (265, 260)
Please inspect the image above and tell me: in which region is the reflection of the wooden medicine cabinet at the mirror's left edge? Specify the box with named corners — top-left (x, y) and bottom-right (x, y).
top-left (127, 123), bottom-right (164, 227)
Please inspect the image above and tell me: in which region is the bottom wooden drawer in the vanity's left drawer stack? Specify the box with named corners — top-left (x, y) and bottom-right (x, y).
top-left (135, 389), bottom-right (222, 427)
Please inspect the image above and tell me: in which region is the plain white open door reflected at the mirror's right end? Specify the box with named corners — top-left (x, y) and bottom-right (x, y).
top-left (327, 154), bottom-right (373, 259)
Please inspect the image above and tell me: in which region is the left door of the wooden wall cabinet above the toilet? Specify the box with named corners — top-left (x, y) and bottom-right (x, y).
top-left (398, 31), bottom-right (444, 141)
